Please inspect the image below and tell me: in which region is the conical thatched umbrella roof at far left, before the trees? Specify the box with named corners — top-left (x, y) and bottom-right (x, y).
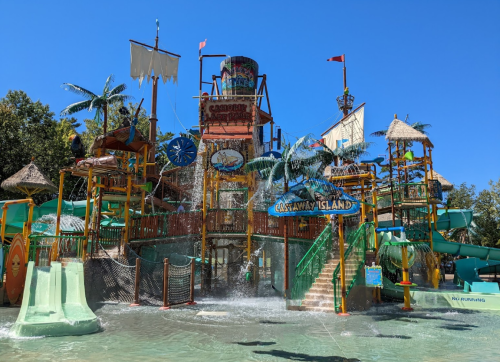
top-left (1, 161), bottom-right (58, 196)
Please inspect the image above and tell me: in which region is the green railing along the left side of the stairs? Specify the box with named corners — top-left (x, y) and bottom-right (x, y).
top-left (291, 224), bottom-right (332, 299)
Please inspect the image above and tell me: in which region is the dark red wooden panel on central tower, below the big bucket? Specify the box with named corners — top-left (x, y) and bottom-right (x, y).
top-left (204, 100), bottom-right (254, 125)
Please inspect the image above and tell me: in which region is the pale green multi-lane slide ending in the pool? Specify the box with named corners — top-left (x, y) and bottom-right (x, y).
top-left (10, 261), bottom-right (99, 337)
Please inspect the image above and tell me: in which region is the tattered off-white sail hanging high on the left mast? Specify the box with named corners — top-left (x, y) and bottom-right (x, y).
top-left (130, 43), bottom-right (179, 87)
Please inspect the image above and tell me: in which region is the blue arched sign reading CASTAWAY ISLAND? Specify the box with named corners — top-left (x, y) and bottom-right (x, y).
top-left (268, 179), bottom-right (360, 216)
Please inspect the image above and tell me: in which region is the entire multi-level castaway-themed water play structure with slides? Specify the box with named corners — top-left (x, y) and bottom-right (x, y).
top-left (0, 33), bottom-right (500, 336)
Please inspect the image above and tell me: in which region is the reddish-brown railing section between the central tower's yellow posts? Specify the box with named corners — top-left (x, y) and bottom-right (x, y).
top-left (207, 209), bottom-right (248, 233)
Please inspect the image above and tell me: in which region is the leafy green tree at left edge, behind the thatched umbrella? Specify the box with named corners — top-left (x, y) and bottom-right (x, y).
top-left (0, 91), bottom-right (80, 204)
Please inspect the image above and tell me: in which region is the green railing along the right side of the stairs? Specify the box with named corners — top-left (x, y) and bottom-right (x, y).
top-left (332, 222), bottom-right (375, 311)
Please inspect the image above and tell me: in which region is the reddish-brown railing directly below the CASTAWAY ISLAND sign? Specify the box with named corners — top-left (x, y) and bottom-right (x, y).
top-left (253, 211), bottom-right (328, 240)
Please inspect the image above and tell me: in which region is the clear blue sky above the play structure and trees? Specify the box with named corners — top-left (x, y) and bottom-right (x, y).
top-left (0, 0), bottom-right (500, 189)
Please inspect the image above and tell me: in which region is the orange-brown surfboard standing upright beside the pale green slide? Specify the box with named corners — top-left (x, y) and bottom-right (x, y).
top-left (5, 234), bottom-right (26, 304)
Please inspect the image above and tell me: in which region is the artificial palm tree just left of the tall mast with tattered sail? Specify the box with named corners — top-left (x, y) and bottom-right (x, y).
top-left (61, 74), bottom-right (132, 134)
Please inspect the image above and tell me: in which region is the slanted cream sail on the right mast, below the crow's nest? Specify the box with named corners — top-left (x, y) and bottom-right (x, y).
top-left (322, 106), bottom-right (365, 150)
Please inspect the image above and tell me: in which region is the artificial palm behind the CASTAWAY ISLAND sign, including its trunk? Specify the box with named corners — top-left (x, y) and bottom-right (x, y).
top-left (245, 135), bottom-right (334, 293)
